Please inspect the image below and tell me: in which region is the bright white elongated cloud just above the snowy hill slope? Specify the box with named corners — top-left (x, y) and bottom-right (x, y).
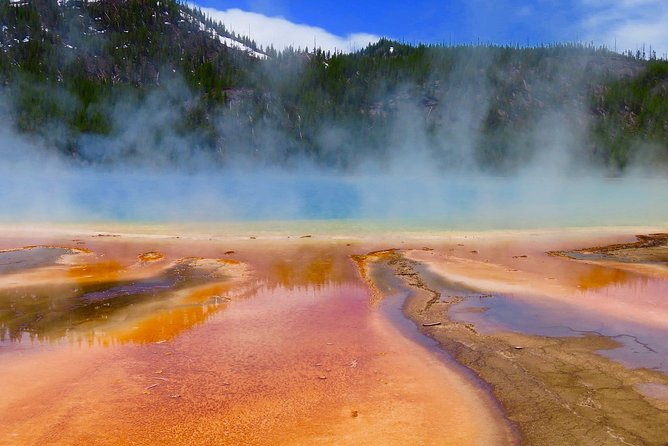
top-left (194, 5), bottom-right (380, 52)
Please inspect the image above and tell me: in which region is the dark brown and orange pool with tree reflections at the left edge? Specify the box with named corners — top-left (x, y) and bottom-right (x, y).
top-left (0, 248), bottom-right (245, 345)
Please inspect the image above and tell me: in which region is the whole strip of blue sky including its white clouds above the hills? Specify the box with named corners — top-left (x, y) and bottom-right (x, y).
top-left (195, 0), bottom-right (668, 57)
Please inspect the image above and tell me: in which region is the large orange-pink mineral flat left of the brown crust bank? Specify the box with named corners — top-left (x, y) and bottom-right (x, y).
top-left (0, 233), bottom-right (515, 445)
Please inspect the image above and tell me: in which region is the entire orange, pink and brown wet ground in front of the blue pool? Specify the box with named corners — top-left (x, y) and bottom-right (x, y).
top-left (0, 227), bottom-right (668, 446)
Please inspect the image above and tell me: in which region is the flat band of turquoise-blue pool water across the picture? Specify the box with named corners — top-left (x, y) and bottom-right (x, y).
top-left (0, 171), bottom-right (668, 229)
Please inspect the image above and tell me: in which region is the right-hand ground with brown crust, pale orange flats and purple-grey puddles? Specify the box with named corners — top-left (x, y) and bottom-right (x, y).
top-left (365, 234), bottom-right (668, 446)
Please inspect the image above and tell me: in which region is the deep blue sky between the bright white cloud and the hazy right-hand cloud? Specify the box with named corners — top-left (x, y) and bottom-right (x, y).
top-left (192, 0), bottom-right (578, 43)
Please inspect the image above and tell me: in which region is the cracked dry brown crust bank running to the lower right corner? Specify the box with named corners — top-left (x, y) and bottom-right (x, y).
top-left (368, 249), bottom-right (668, 446)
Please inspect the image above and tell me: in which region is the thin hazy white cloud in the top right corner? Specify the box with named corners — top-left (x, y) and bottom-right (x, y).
top-left (581, 0), bottom-right (668, 57)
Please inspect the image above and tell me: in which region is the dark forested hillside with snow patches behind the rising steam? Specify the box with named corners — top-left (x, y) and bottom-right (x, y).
top-left (0, 0), bottom-right (668, 172)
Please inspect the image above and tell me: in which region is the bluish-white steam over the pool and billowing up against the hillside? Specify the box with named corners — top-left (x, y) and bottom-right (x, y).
top-left (0, 48), bottom-right (668, 229)
